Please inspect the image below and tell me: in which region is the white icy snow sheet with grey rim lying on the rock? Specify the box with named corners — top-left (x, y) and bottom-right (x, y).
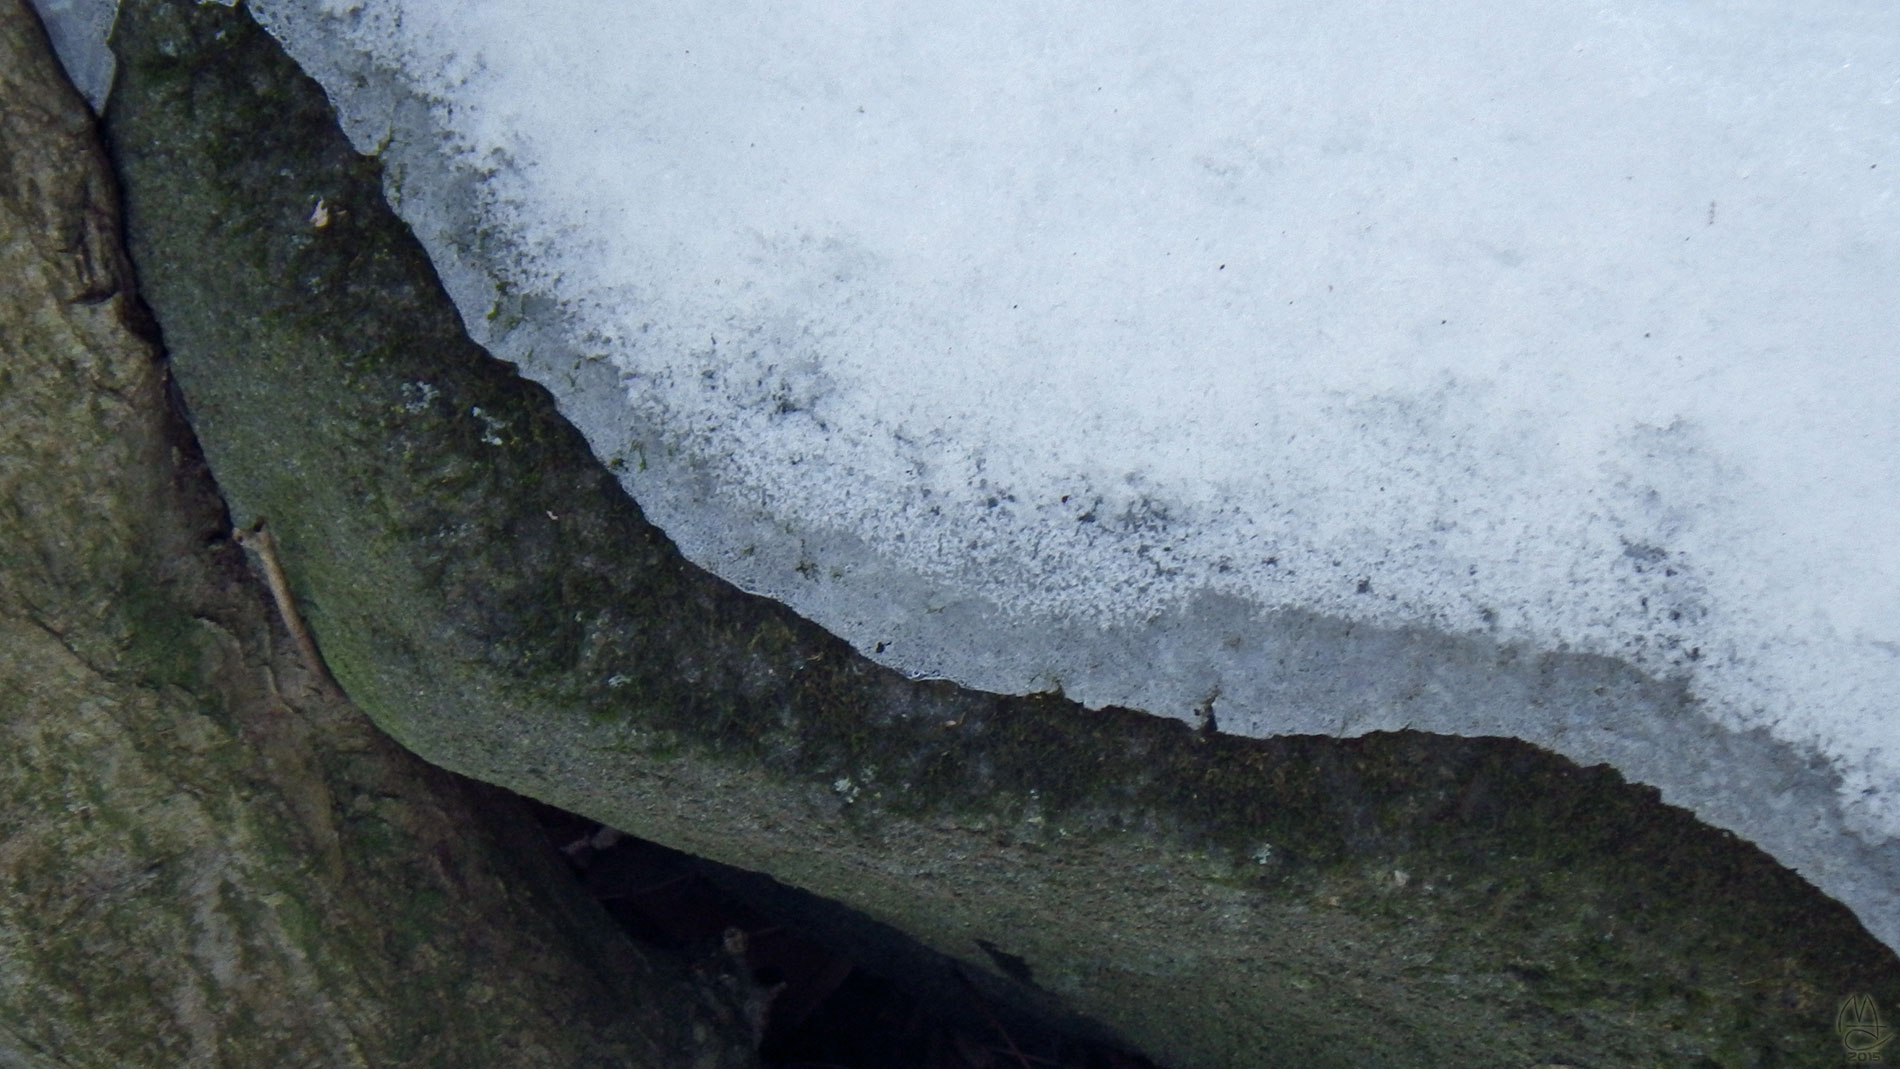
top-left (241, 0), bottom-right (1900, 930)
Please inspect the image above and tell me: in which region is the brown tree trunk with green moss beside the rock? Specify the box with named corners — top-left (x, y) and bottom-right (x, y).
top-left (0, 0), bottom-right (751, 1069)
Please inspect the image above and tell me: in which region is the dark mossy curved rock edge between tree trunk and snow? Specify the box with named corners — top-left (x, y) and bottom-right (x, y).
top-left (110, 0), bottom-right (1900, 1067)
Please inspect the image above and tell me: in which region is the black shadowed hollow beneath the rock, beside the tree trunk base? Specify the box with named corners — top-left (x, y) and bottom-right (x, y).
top-left (528, 799), bottom-right (1155, 1069)
